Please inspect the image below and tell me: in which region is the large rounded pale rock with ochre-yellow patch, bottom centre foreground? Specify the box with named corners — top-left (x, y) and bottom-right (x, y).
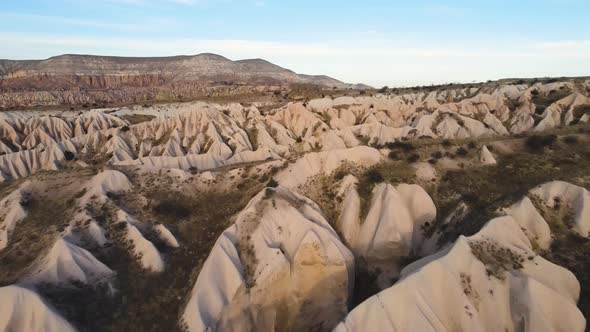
top-left (183, 187), bottom-right (354, 331)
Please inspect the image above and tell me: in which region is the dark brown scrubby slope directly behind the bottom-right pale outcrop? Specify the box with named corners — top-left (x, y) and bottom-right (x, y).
top-left (427, 134), bottom-right (590, 246)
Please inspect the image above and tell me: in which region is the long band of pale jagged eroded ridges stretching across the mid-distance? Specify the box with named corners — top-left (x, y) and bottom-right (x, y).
top-left (0, 78), bottom-right (590, 182)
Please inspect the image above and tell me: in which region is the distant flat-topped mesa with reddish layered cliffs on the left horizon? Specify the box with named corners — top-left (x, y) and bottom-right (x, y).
top-left (0, 54), bottom-right (348, 107)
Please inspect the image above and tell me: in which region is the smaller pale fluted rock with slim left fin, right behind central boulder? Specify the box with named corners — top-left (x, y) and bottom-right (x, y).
top-left (337, 180), bottom-right (436, 288)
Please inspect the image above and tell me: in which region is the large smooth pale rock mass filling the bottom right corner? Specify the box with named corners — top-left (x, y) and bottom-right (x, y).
top-left (335, 182), bottom-right (589, 332)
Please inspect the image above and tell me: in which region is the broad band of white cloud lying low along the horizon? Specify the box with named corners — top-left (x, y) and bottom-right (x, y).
top-left (0, 33), bottom-right (590, 86)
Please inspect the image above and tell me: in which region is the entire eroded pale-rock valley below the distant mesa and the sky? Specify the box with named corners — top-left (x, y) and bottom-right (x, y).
top-left (0, 82), bottom-right (590, 331)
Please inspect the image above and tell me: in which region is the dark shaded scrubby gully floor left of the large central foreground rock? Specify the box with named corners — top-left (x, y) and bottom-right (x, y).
top-left (40, 188), bottom-right (250, 332)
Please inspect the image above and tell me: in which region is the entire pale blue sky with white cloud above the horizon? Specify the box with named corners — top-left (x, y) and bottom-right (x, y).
top-left (0, 0), bottom-right (590, 86)
